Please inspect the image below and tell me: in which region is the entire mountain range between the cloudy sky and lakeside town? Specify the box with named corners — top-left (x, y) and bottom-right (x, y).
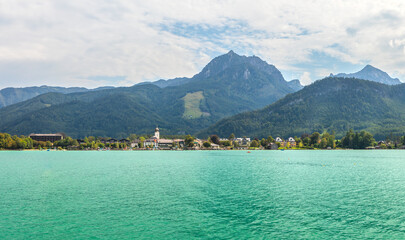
top-left (0, 51), bottom-right (405, 138)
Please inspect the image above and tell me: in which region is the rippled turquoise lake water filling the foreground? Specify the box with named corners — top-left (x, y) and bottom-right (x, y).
top-left (0, 150), bottom-right (405, 239)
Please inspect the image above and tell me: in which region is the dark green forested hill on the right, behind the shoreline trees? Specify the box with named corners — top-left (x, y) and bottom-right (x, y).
top-left (199, 78), bottom-right (405, 139)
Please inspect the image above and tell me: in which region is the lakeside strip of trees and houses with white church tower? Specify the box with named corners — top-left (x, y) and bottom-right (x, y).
top-left (0, 128), bottom-right (405, 150)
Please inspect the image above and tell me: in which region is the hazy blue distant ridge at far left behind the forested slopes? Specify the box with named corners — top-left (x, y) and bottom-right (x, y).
top-left (0, 86), bottom-right (112, 108)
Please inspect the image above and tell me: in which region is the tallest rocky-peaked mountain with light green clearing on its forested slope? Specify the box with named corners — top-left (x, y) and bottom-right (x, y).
top-left (0, 51), bottom-right (294, 137)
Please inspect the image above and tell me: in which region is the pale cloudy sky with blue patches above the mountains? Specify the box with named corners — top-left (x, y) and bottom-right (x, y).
top-left (0, 0), bottom-right (405, 89)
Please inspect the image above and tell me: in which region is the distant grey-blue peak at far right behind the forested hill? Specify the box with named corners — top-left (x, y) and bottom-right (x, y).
top-left (331, 65), bottom-right (401, 85)
